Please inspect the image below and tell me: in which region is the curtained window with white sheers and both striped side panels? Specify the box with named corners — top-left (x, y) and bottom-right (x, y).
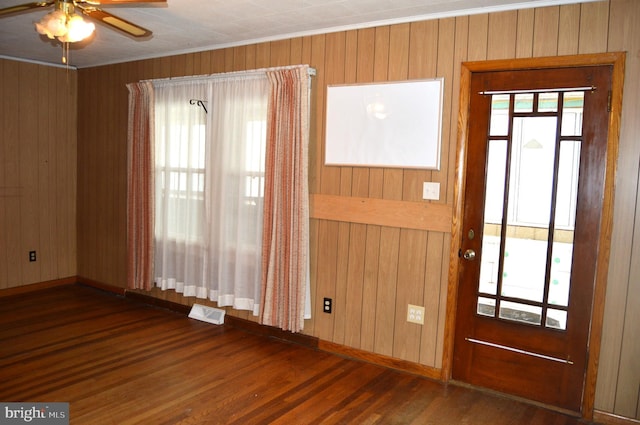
top-left (127, 65), bottom-right (315, 332)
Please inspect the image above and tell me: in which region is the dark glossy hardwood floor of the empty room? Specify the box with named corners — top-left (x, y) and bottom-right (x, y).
top-left (0, 285), bottom-right (592, 425)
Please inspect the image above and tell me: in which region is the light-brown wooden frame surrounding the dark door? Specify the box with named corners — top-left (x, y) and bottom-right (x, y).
top-left (441, 52), bottom-right (625, 420)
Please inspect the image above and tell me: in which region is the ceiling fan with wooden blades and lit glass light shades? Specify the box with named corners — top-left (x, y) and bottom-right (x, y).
top-left (0, 0), bottom-right (166, 42)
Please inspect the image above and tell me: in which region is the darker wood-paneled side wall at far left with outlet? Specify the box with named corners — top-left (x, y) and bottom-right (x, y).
top-left (0, 59), bottom-right (77, 289)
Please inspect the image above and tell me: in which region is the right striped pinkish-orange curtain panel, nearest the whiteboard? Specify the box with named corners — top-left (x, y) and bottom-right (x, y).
top-left (261, 65), bottom-right (309, 332)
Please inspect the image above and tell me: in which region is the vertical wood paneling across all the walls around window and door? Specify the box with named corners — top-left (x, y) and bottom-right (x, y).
top-left (0, 0), bottom-right (620, 418)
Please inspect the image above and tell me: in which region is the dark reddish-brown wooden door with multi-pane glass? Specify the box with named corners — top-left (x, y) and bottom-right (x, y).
top-left (452, 66), bottom-right (612, 412)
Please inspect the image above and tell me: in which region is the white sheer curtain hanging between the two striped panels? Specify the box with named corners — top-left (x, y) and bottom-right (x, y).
top-left (153, 73), bottom-right (269, 315)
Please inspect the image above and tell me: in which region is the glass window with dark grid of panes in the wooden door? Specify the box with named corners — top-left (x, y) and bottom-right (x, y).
top-left (477, 91), bottom-right (584, 330)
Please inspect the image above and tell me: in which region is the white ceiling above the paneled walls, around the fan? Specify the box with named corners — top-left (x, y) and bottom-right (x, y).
top-left (0, 0), bottom-right (597, 68)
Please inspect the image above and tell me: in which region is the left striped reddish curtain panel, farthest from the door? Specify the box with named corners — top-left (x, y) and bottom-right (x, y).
top-left (127, 81), bottom-right (154, 290)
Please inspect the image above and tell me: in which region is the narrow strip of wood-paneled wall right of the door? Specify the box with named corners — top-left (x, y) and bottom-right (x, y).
top-left (596, 0), bottom-right (640, 419)
